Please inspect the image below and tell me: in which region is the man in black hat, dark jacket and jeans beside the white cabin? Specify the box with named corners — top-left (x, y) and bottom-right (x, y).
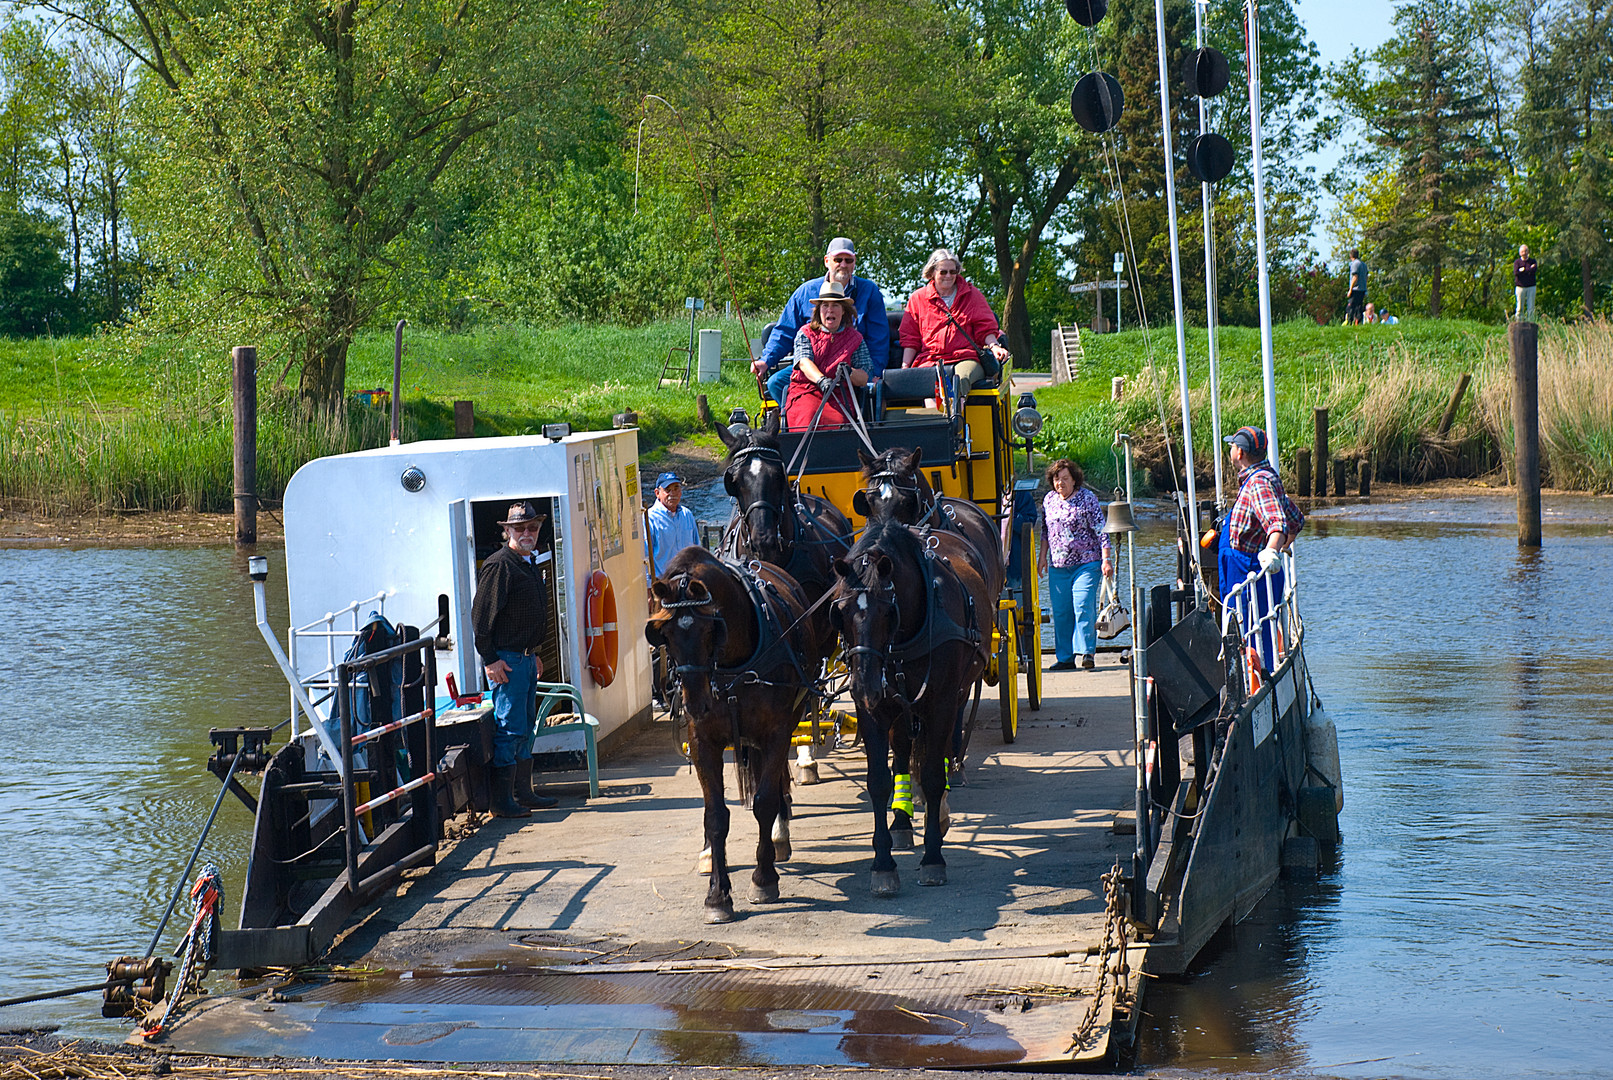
top-left (471, 501), bottom-right (555, 817)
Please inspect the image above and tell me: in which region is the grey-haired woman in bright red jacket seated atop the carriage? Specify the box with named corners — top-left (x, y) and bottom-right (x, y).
top-left (900, 248), bottom-right (1010, 395)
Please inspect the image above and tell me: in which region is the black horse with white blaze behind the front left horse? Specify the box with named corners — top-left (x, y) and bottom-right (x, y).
top-left (716, 409), bottom-right (852, 637)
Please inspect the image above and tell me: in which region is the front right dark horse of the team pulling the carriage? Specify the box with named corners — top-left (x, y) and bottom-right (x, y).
top-left (831, 521), bottom-right (997, 896)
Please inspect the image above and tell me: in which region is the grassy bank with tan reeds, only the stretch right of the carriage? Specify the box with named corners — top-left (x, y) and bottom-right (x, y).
top-left (1039, 321), bottom-right (1613, 492)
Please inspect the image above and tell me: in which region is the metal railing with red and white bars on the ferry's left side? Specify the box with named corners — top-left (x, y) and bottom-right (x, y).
top-left (336, 637), bottom-right (437, 898)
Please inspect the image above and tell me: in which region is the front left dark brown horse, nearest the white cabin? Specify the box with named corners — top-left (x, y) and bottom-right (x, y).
top-left (644, 548), bottom-right (823, 922)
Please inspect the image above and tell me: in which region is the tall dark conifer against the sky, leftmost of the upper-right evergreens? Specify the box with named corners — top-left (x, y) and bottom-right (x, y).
top-left (1332, 0), bottom-right (1497, 318)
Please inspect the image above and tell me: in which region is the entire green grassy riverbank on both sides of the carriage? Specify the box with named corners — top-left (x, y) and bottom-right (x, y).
top-left (0, 321), bottom-right (1613, 513)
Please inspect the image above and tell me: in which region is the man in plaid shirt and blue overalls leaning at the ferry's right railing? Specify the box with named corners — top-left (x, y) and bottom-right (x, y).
top-left (1216, 427), bottom-right (1305, 671)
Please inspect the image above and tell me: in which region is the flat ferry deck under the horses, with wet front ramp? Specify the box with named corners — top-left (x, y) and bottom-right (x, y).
top-left (157, 667), bottom-right (1142, 1069)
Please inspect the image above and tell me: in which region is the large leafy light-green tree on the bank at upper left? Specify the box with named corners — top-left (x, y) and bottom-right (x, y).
top-left (25, 0), bottom-right (642, 411)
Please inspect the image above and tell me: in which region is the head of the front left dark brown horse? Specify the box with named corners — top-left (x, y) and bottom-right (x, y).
top-left (644, 548), bottom-right (729, 714)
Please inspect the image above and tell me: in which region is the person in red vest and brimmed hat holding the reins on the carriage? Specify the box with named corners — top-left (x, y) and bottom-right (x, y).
top-left (784, 280), bottom-right (874, 432)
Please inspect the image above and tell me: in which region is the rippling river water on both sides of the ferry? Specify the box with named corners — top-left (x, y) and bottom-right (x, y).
top-left (0, 496), bottom-right (1613, 1078)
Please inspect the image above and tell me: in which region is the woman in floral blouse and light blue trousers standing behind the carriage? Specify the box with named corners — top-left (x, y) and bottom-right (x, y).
top-left (1036, 458), bottom-right (1115, 671)
